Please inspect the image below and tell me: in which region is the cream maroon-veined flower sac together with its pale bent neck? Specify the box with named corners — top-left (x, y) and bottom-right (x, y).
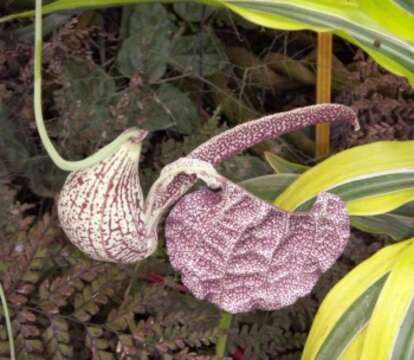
top-left (58, 130), bottom-right (220, 263)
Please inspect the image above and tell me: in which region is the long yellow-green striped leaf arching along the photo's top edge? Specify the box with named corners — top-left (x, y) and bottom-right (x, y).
top-left (0, 0), bottom-right (414, 83)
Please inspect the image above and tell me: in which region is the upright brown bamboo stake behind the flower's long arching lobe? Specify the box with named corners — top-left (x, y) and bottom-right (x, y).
top-left (316, 32), bottom-right (332, 159)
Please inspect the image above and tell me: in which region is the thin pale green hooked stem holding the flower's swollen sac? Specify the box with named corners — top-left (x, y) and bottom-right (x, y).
top-left (34, 0), bottom-right (140, 171)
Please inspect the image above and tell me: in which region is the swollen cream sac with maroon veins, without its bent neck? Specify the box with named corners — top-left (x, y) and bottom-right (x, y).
top-left (58, 131), bottom-right (150, 263)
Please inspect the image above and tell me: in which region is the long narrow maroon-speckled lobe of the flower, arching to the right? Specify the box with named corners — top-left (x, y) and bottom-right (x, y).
top-left (146, 104), bottom-right (359, 224)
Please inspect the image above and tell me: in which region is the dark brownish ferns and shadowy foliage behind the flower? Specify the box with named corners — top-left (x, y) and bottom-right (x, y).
top-left (0, 1), bottom-right (414, 360)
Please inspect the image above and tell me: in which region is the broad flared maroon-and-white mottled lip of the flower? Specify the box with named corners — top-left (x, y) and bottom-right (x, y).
top-left (165, 180), bottom-right (350, 313)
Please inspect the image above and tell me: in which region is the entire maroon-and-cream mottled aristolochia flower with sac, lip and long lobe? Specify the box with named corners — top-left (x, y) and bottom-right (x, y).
top-left (58, 104), bottom-right (357, 312)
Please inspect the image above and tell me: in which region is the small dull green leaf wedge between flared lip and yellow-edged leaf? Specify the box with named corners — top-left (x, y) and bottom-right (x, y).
top-left (239, 174), bottom-right (297, 202)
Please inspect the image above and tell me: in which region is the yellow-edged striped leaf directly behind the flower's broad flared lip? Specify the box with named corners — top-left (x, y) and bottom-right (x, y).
top-left (274, 141), bottom-right (414, 215)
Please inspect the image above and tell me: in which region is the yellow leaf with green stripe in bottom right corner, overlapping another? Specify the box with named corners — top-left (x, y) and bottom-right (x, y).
top-left (361, 240), bottom-right (414, 360)
